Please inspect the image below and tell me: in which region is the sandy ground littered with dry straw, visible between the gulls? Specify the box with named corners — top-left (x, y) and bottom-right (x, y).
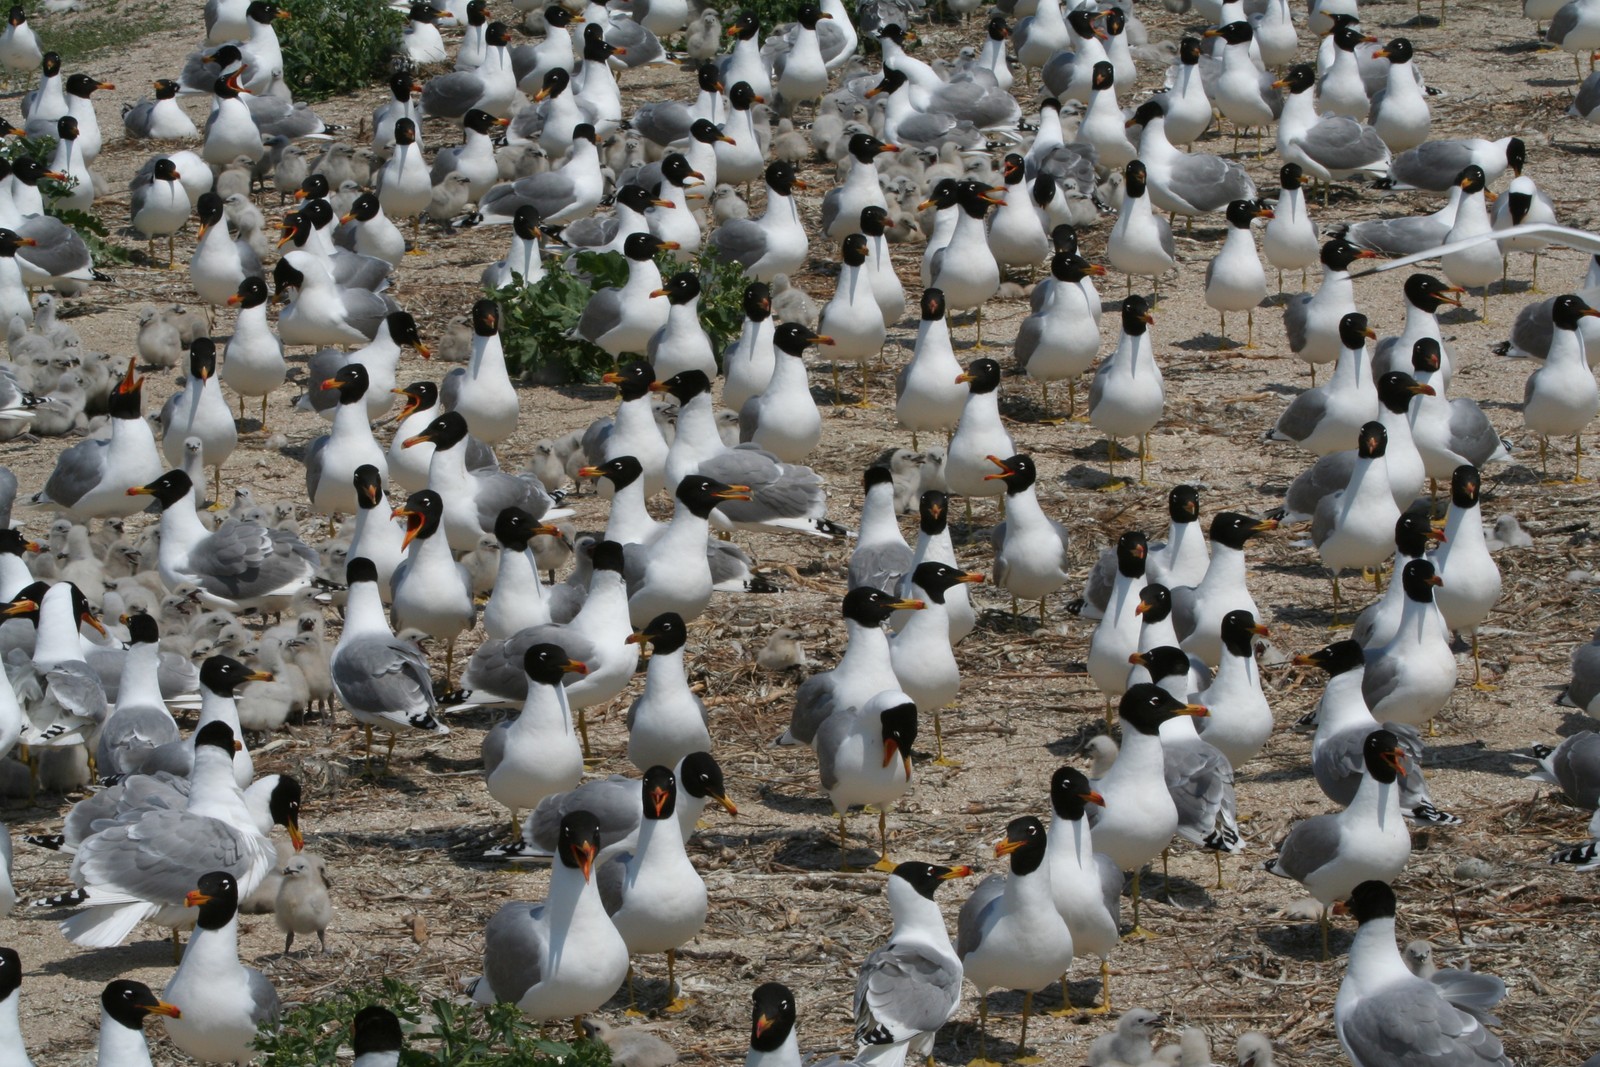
top-left (0, 0), bottom-right (1600, 1067)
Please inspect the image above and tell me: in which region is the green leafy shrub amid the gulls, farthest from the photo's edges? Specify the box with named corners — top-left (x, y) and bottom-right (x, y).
top-left (488, 251), bottom-right (746, 384)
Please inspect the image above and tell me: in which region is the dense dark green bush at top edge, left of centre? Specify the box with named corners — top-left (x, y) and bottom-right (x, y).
top-left (277, 0), bottom-right (405, 101)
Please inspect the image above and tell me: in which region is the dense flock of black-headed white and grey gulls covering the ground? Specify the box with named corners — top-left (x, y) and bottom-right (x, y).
top-left (0, 0), bottom-right (1600, 1067)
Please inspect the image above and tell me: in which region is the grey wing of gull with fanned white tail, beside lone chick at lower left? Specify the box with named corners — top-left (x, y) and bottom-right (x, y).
top-left (72, 811), bottom-right (250, 907)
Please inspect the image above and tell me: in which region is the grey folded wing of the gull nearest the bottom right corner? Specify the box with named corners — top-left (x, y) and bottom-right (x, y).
top-left (1338, 977), bottom-right (1510, 1067)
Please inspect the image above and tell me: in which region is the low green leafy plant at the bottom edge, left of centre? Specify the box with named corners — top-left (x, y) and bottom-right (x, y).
top-left (256, 977), bottom-right (611, 1067)
